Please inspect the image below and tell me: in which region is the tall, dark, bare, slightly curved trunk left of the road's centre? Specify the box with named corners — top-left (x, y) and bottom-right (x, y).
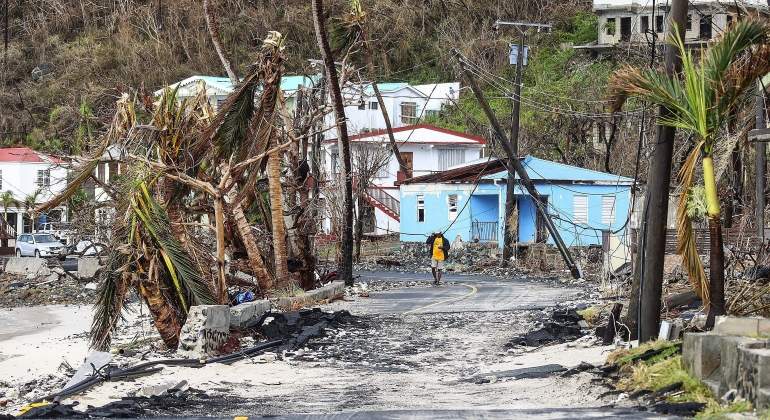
top-left (313, 0), bottom-right (353, 286)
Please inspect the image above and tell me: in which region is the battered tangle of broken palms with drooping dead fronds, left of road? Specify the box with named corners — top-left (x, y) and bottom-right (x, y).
top-left (36, 32), bottom-right (296, 349)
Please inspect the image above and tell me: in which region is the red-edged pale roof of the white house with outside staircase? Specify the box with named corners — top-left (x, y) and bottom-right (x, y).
top-left (325, 124), bottom-right (486, 145)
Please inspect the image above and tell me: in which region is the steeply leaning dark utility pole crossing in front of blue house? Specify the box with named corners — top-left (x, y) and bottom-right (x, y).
top-left (452, 49), bottom-right (583, 279)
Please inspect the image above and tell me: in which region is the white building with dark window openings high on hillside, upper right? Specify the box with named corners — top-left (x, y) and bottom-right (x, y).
top-left (576, 0), bottom-right (767, 50)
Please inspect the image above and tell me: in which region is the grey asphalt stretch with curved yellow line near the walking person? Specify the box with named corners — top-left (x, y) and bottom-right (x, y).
top-left (344, 271), bottom-right (579, 314)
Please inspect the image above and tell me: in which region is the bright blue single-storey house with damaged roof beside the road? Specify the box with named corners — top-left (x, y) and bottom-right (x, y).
top-left (400, 156), bottom-right (634, 247)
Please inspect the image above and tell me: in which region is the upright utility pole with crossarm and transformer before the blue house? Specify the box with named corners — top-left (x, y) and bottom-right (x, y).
top-left (494, 20), bottom-right (551, 266)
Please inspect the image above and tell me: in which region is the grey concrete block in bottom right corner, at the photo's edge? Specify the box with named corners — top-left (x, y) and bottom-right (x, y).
top-left (737, 343), bottom-right (770, 410)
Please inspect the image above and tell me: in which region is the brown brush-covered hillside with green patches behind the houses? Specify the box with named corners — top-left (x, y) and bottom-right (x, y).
top-left (0, 0), bottom-right (648, 174)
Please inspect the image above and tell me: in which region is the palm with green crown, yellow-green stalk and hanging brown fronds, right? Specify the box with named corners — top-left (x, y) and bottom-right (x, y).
top-left (610, 20), bottom-right (770, 327)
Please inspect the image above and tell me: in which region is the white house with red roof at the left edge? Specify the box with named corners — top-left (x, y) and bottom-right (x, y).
top-left (0, 147), bottom-right (68, 234)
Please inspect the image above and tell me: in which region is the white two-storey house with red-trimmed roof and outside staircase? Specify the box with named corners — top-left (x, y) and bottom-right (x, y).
top-left (323, 124), bottom-right (486, 234)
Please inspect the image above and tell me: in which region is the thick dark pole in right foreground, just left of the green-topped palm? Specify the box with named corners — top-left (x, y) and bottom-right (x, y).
top-left (638, 0), bottom-right (687, 343)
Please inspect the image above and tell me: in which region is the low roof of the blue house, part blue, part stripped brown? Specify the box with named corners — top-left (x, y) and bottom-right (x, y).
top-left (402, 155), bottom-right (634, 185)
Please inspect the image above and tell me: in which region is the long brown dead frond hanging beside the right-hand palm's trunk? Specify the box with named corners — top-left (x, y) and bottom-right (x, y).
top-left (676, 141), bottom-right (709, 306)
